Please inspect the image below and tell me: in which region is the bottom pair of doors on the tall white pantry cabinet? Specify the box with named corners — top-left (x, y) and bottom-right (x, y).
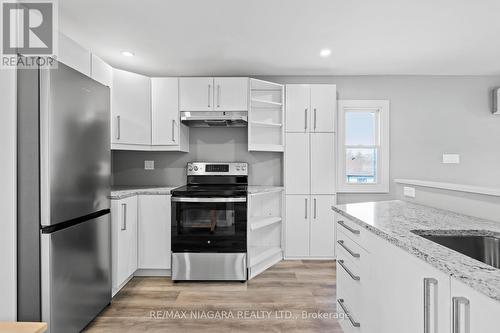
top-left (285, 195), bottom-right (336, 259)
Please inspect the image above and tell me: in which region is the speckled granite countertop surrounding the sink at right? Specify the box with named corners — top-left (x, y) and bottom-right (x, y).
top-left (332, 200), bottom-right (500, 302)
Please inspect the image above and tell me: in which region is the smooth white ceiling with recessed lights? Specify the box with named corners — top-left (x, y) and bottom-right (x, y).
top-left (59, 0), bottom-right (500, 76)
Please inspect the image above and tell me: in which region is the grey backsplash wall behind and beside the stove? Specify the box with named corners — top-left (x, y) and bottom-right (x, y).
top-left (112, 128), bottom-right (283, 186)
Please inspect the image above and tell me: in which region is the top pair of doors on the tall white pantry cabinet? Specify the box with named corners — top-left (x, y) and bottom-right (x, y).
top-left (286, 84), bottom-right (337, 133)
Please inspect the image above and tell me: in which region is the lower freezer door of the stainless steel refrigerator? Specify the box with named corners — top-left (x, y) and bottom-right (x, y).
top-left (41, 213), bottom-right (111, 333)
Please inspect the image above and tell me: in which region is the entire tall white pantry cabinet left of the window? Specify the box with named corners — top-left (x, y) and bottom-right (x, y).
top-left (285, 84), bottom-right (337, 259)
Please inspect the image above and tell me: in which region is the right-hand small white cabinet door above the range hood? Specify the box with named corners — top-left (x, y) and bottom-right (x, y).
top-left (214, 77), bottom-right (248, 111)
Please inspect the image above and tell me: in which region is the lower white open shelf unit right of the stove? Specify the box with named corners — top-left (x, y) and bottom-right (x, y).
top-left (247, 188), bottom-right (283, 279)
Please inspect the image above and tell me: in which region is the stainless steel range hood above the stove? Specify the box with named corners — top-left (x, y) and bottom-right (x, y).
top-left (181, 111), bottom-right (248, 127)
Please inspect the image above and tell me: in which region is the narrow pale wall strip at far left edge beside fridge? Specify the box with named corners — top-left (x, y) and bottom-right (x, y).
top-left (0, 69), bottom-right (17, 321)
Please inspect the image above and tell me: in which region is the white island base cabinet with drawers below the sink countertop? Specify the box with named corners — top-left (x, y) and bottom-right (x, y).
top-left (336, 216), bottom-right (500, 333)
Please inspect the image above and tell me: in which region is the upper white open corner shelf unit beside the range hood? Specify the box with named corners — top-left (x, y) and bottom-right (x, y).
top-left (248, 79), bottom-right (285, 152)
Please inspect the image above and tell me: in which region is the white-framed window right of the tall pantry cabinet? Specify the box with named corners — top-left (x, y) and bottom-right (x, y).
top-left (337, 100), bottom-right (389, 193)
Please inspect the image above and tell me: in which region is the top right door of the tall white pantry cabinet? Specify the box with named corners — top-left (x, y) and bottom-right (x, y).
top-left (311, 84), bottom-right (337, 133)
